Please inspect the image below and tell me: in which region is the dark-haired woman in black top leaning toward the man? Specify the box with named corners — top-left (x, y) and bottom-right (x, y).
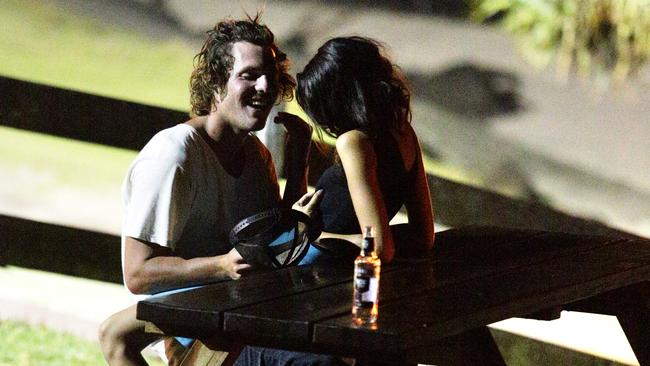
top-left (296, 37), bottom-right (434, 262)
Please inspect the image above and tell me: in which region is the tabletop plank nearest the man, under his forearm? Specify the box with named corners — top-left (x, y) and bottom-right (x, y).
top-left (137, 265), bottom-right (352, 336)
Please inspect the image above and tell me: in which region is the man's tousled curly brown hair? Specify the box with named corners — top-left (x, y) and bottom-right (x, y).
top-left (190, 13), bottom-right (296, 116)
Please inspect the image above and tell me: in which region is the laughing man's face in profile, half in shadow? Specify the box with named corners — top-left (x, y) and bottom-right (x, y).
top-left (215, 42), bottom-right (278, 133)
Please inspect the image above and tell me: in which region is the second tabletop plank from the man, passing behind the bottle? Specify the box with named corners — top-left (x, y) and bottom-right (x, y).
top-left (224, 228), bottom-right (625, 349)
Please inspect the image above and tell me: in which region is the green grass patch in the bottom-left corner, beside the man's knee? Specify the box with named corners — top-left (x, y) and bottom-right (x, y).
top-left (0, 320), bottom-right (164, 366)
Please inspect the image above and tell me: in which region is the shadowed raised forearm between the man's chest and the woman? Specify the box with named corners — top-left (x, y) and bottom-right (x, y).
top-left (274, 112), bottom-right (312, 207)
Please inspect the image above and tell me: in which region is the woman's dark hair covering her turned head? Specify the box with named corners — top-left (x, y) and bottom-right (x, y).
top-left (296, 37), bottom-right (411, 138)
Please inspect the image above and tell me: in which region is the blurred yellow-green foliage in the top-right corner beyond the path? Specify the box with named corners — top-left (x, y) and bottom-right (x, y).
top-left (472, 0), bottom-right (650, 85)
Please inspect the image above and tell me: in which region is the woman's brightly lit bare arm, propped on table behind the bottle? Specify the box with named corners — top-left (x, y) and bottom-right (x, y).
top-left (336, 130), bottom-right (395, 263)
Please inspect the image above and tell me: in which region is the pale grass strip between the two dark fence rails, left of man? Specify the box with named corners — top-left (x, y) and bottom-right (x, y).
top-left (0, 126), bottom-right (136, 234)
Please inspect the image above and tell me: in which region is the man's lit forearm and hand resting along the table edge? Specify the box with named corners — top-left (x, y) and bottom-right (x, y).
top-left (124, 237), bottom-right (250, 294)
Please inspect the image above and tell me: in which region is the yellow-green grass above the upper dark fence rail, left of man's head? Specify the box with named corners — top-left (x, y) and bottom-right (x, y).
top-left (0, 0), bottom-right (195, 110)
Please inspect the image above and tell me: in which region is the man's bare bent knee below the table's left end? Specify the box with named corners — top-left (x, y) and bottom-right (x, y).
top-left (99, 305), bottom-right (161, 366)
